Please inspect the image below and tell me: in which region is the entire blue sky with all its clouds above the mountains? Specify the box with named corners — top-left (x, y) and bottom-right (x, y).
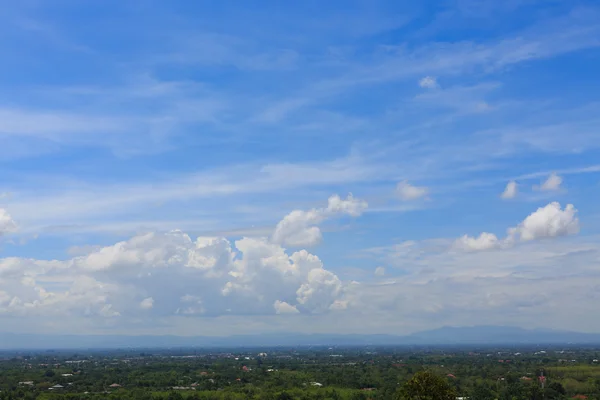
top-left (0, 0), bottom-right (600, 335)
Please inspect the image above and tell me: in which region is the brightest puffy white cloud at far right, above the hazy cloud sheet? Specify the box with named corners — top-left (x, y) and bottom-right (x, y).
top-left (509, 202), bottom-right (579, 241)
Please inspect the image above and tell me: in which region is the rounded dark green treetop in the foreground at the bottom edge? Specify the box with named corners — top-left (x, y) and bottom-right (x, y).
top-left (395, 371), bottom-right (456, 400)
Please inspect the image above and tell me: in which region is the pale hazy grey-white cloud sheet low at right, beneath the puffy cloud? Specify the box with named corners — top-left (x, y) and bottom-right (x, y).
top-left (350, 230), bottom-right (600, 331)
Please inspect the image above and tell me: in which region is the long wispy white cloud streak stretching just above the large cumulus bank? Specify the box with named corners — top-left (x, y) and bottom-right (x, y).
top-left (2, 153), bottom-right (394, 231)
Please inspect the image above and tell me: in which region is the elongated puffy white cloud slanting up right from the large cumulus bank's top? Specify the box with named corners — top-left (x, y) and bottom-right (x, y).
top-left (271, 194), bottom-right (367, 247)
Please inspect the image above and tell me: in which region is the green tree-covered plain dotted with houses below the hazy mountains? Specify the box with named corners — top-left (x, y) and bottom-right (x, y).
top-left (0, 346), bottom-right (600, 400)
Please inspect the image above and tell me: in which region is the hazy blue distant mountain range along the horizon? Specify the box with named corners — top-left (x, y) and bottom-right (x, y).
top-left (0, 326), bottom-right (600, 349)
